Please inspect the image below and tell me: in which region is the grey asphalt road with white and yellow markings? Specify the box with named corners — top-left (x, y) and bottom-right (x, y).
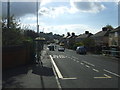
top-left (49, 46), bottom-right (120, 88)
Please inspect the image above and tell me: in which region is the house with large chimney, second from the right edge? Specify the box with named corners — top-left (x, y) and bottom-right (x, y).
top-left (91, 27), bottom-right (111, 54)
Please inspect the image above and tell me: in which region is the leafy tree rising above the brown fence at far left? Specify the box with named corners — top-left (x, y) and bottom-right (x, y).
top-left (2, 16), bottom-right (23, 46)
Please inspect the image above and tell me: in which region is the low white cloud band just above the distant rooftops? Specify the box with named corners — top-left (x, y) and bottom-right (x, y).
top-left (41, 24), bottom-right (100, 35)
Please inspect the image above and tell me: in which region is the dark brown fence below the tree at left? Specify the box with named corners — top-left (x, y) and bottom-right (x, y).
top-left (2, 44), bottom-right (33, 69)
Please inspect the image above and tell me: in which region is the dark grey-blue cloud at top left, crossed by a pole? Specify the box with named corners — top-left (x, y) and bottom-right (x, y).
top-left (2, 2), bottom-right (39, 17)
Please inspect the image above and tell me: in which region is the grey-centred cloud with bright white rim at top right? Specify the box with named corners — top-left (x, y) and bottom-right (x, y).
top-left (70, 0), bottom-right (106, 13)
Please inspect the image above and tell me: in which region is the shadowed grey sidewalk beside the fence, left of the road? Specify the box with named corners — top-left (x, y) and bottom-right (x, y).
top-left (2, 50), bottom-right (58, 88)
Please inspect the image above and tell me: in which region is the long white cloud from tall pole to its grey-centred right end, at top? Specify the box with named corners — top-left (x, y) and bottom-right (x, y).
top-left (39, 0), bottom-right (106, 18)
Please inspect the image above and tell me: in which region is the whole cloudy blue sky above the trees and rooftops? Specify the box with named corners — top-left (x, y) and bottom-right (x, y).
top-left (2, 0), bottom-right (119, 35)
